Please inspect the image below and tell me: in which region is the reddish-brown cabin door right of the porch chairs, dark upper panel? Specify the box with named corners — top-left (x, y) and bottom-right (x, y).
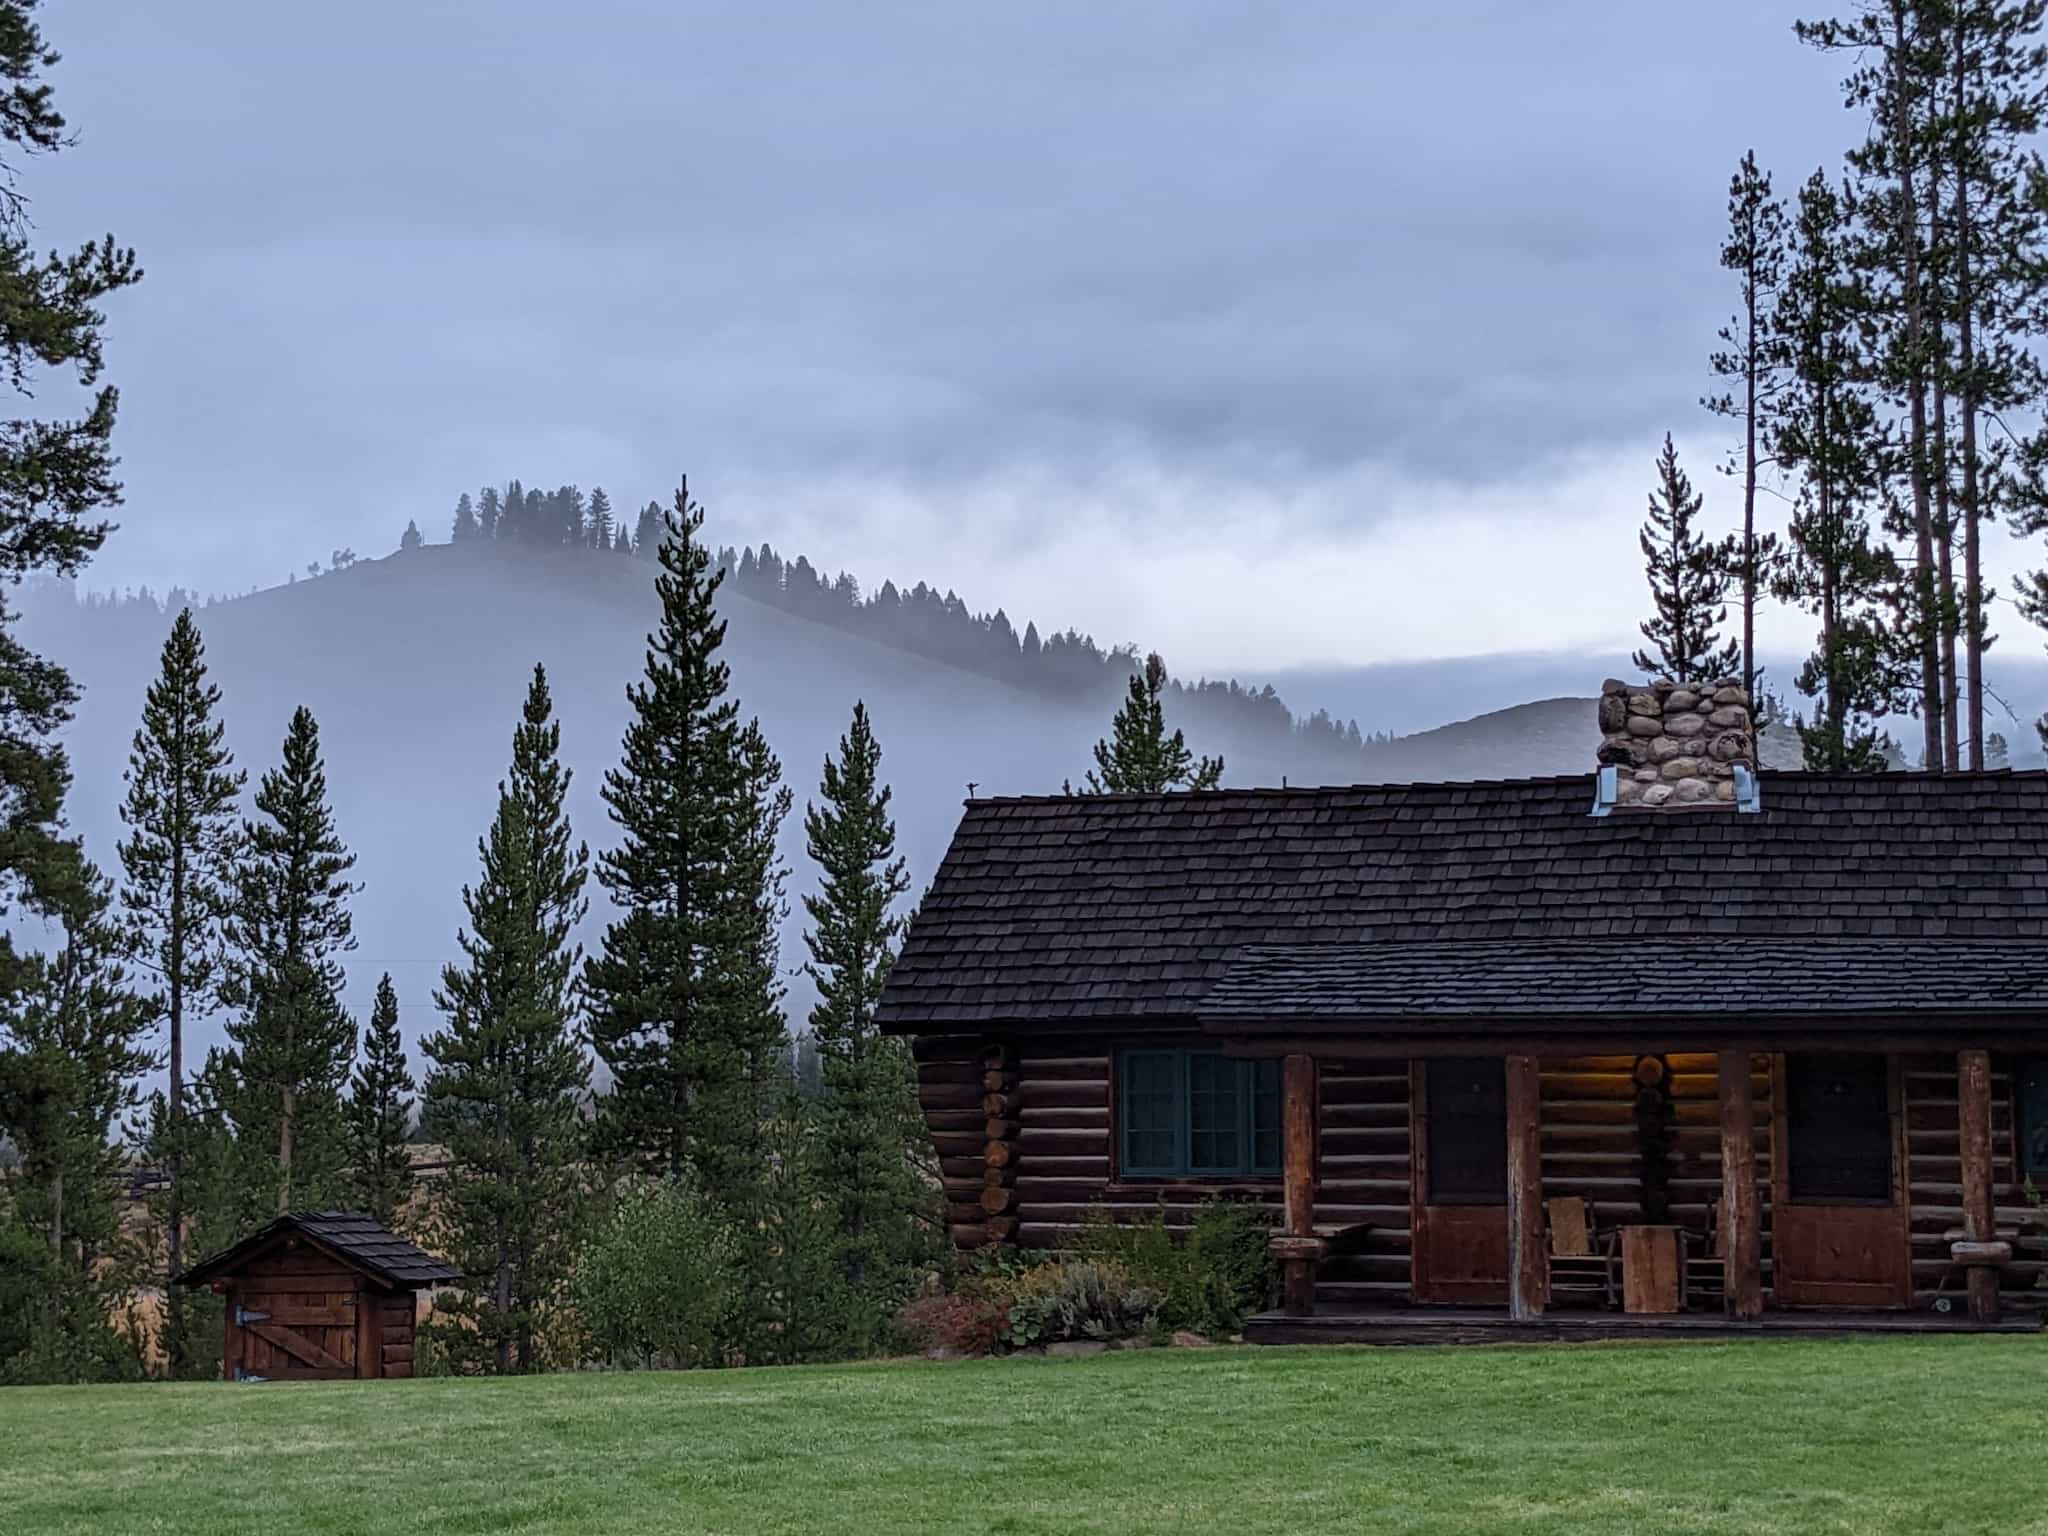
top-left (1772, 1053), bottom-right (1913, 1307)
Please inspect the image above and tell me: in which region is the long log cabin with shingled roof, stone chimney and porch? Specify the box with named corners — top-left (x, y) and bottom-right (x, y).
top-left (881, 682), bottom-right (2048, 1341)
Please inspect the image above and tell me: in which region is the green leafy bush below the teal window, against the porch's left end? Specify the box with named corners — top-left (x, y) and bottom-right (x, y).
top-left (1073, 1200), bottom-right (1274, 1333)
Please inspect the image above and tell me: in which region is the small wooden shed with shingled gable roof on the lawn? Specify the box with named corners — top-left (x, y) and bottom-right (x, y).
top-left (184, 1210), bottom-right (461, 1380)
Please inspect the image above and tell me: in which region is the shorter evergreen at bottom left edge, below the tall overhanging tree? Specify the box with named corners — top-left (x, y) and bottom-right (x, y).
top-left (0, 868), bottom-right (156, 1380)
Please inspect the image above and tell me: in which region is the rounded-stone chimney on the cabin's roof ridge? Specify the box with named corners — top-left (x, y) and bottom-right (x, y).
top-left (1599, 678), bottom-right (1757, 811)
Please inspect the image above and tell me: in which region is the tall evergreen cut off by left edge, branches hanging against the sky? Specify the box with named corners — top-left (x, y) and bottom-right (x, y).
top-left (0, 0), bottom-right (141, 1015)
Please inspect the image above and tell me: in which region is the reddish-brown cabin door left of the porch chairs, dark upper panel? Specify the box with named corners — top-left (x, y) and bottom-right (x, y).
top-left (1409, 1057), bottom-right (1507, 1305)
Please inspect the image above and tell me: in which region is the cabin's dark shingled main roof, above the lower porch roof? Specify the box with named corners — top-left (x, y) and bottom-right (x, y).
top-left (881, 772), bottom-right (2048, 1030)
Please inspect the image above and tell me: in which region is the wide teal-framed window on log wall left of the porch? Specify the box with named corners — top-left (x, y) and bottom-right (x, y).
top-left (1116, 1049), bottom-right (1280, 1180)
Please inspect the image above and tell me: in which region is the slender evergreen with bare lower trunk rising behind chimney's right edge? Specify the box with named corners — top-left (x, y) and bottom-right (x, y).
top-left (1702, 150), bottom-right (1786, 702)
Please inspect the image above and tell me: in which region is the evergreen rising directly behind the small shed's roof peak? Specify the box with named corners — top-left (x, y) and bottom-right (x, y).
top-left (221, 705), bottom-right (356, 1221)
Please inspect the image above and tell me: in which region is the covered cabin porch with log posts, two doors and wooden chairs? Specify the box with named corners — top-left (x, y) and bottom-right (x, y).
top-left (1231, 1032), bottom-right (2040, 1343)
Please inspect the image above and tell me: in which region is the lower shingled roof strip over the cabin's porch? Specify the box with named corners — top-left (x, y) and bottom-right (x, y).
top-left (1196, 936), bottom-right (2048, 1040)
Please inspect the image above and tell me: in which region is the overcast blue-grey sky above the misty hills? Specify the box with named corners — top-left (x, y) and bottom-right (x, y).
top-left (27, 0), bottom-right (2048, 670)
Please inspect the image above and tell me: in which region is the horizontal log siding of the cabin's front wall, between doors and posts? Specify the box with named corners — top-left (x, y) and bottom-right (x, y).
top-left (918, 1036), bottom-right (2048, 1307)
